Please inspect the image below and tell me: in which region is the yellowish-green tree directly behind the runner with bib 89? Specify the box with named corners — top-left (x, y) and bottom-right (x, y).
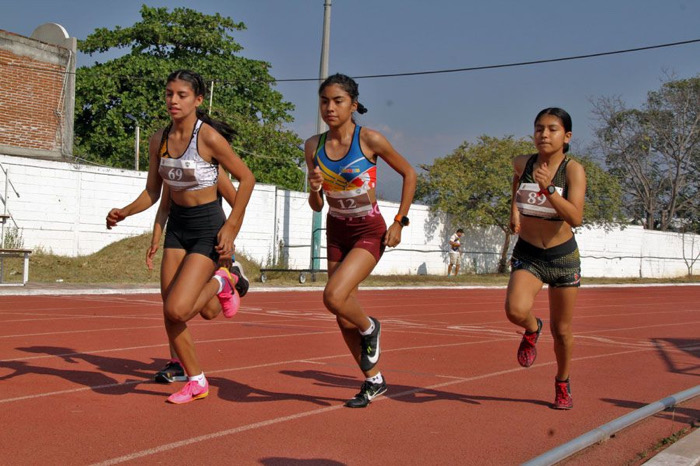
top-left (416, 136), bottom-right (621, 273)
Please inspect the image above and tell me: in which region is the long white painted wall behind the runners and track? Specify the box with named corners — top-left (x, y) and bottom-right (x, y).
top-left (0, 155), bottom-right (700, 277)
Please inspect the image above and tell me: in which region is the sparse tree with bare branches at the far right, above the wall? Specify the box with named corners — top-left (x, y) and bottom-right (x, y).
top-left (594, 77), bottom-right (700, 230)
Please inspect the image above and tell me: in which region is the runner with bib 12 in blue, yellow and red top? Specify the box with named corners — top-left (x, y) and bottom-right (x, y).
top-left (304, 74), bottom-right (416, 408)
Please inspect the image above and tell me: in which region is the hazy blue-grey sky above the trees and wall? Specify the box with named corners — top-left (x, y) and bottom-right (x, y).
top-left (0, 0), bottom-right (700, 200)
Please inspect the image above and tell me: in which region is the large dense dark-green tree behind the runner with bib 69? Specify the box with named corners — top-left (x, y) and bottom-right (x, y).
top-left (75, 5), bottom-right (303, 189)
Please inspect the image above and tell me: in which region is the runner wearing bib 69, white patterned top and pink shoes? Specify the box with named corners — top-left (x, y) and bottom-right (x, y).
top-left (106, 70), bottom-right (255, 404)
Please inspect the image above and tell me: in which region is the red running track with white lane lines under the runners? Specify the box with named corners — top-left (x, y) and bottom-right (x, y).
top-left (0, 286), bottom-right (700, 465)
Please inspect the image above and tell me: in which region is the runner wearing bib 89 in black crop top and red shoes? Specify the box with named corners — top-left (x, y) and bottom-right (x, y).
top-left (505, 108), bottom-right (586, 409)
